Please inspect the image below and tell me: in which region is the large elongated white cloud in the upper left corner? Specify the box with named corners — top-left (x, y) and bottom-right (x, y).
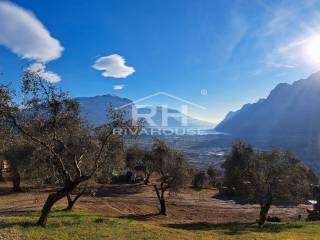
top-left (0, 1), bottom-right (63, 62)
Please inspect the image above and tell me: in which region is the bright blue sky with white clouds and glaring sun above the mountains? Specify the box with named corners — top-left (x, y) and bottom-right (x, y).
top-left (0, 0), bottom-right (320, 123)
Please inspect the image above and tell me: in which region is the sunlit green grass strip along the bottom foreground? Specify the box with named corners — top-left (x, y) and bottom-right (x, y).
top-left (0, 210), bottom-right (320, 240)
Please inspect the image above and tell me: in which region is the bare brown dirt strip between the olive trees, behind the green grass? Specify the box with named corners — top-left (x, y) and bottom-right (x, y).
top-left (0, 185), bottom-right (306, 223)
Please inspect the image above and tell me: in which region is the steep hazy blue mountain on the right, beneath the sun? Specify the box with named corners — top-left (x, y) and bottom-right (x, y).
top-left (215, 72), bottom-right (320, 170)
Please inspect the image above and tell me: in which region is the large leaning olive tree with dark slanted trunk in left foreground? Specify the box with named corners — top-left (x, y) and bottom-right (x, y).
top-left (0, 68), bottom-right (127, 226)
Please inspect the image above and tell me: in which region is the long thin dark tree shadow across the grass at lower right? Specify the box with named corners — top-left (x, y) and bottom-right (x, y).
top-left (164, 222), bottom-right (303, 235)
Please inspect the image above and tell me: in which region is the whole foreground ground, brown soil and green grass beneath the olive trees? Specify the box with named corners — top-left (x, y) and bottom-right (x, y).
top-left (0, 185), bottom-right (320, 240)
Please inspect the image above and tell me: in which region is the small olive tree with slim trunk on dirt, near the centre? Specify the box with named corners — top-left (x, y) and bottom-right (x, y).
top-left (152, 140), bottom-right (190, 215)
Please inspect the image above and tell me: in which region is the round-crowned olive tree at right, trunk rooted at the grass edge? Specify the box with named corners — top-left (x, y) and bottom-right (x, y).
top-left (244, 150), bottom-right (316, 225)
